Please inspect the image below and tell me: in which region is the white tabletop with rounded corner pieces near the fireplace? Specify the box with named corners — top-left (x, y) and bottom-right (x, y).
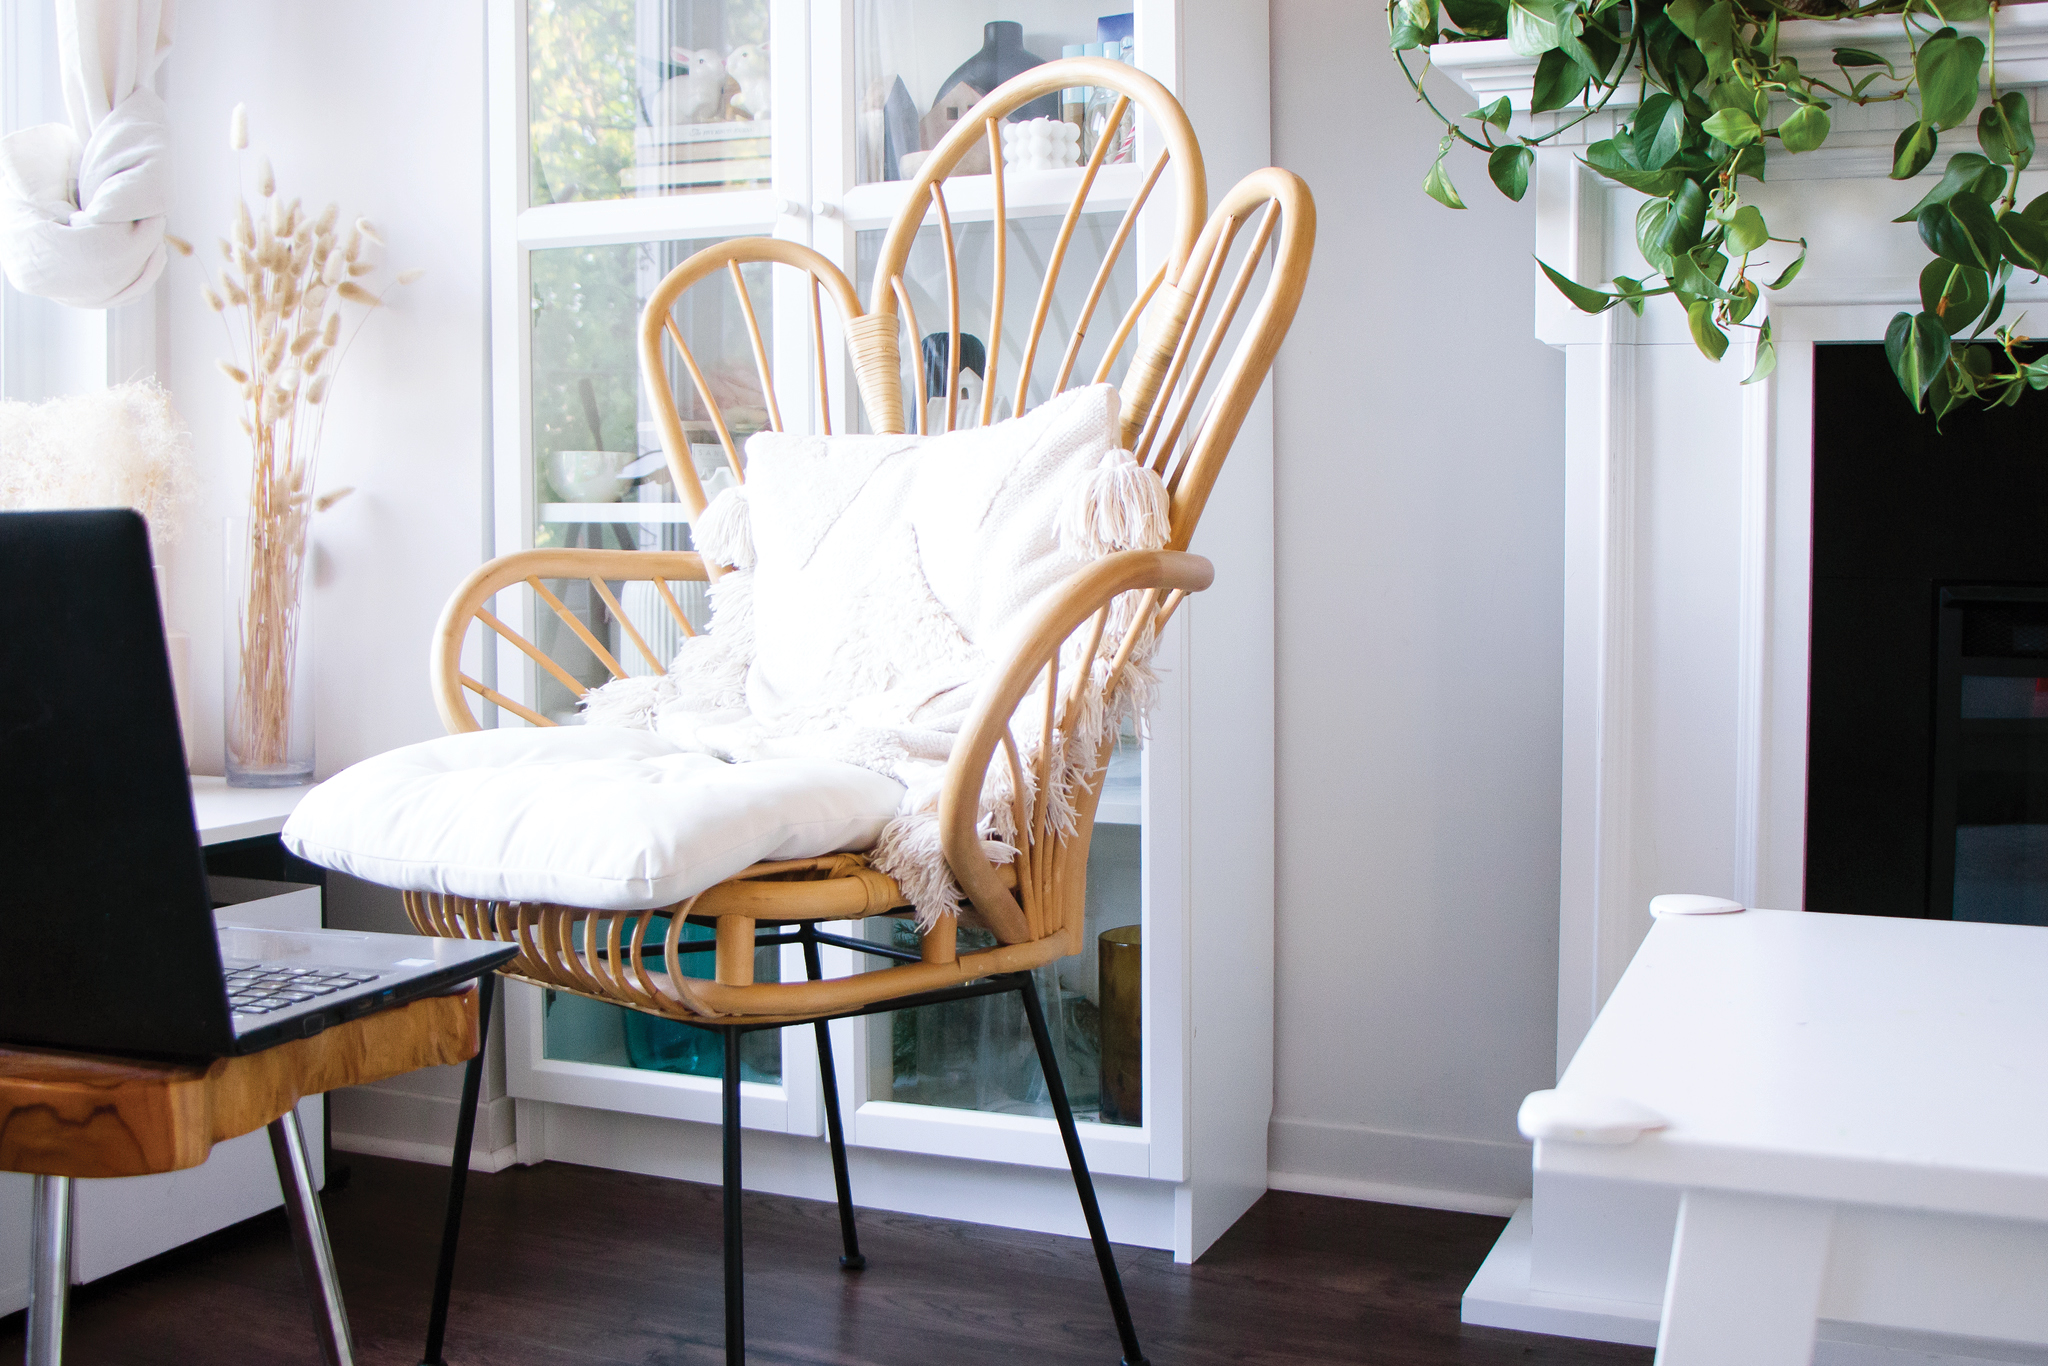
top-left (1536, 911), bottom-right (2048, 1221)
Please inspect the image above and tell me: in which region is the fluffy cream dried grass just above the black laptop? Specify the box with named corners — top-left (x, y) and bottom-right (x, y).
top-left (0, 381), bottom-right (193, 545)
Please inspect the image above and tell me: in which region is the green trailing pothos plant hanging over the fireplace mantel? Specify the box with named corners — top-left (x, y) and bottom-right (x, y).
top-left (1389, 0), bottom-right (2048, 420)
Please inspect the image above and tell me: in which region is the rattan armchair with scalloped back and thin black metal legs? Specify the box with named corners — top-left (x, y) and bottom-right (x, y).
top-left (406, 59), bottom-right (1315, 1364)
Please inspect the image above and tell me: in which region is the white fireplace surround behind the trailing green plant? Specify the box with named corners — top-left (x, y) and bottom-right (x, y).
top-left (1432, 37), bottom-right (2048, 1071)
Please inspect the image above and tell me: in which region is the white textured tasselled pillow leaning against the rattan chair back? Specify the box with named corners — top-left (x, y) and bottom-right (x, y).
top-left (745, 385), bottom-right (1118, 717)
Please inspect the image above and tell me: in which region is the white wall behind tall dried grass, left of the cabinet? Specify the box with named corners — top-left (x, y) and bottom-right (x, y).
top-left (158, 0), bottom-right (510, 1149)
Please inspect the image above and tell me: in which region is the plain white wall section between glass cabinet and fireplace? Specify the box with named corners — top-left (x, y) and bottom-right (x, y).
top-left (1272, 0), bottom-right (1565, 1208)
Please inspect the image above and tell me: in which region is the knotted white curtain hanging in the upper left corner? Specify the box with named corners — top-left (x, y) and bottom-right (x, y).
top-left (0, 0), bottom-right (172, 309)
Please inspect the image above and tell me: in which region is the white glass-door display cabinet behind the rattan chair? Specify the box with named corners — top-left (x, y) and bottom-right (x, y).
top-left (485, 0), bottom-right (1272, 1257)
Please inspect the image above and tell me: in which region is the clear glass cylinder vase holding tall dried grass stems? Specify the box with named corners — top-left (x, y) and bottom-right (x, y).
top-left (221, 512), bottom-right (313, 786)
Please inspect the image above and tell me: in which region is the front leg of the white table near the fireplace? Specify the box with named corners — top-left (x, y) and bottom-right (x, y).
top-left (1657, 1190), bottom-right (1835, 1366)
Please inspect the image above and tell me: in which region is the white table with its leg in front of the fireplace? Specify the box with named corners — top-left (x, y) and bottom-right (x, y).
top-left (1534, 911), bottom-right (2048, 1366)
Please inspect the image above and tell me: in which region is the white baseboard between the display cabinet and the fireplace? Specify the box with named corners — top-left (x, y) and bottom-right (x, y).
top-left (1268, 1118), bottom-right (1530, 1216)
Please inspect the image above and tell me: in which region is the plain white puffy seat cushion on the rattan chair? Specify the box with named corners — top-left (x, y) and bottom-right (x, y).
top-left (283, 725), bottom-right (903, 911)
